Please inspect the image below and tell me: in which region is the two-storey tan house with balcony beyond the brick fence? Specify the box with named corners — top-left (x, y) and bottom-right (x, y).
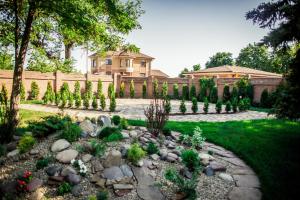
top-left (90, 50), bottom-right (154, 77)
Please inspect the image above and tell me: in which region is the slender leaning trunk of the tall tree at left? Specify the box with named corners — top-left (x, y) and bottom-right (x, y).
top-left (8, 5), bottom-right (36, 137)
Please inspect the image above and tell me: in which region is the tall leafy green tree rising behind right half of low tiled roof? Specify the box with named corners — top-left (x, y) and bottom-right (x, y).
top-left (236, 43), bottom-right (273, 72)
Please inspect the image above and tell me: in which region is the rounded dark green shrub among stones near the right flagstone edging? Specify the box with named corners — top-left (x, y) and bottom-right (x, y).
top-left (180, 149), bottom-right (200, 171)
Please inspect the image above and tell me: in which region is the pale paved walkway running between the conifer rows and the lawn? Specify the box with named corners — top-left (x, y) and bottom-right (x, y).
top-left (20, 99), bottom-right (273, 122)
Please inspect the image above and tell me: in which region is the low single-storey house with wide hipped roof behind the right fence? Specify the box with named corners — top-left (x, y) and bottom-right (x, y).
top-left (184, 65), bottom-right (282, 78)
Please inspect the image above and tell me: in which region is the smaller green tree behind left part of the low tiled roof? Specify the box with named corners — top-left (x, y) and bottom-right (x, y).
top-left (205, 52), bottom-right (234, 68)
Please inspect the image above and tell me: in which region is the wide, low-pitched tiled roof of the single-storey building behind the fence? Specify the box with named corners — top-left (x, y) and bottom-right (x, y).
top-left (186, 65), bottom-right (282, 77)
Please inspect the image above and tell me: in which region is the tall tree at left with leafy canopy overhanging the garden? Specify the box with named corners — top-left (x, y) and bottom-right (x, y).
top-left (0, 0), bottom-right (143, 140)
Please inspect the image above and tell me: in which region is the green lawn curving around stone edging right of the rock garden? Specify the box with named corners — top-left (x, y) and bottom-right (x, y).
top-left (129, 119), bottom-right (300, 200)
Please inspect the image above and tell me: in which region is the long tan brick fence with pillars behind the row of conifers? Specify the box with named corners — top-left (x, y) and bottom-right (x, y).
top-left (0, 70), bottom-right (282, 102)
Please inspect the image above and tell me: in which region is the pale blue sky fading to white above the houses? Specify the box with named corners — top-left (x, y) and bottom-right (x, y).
top-left (73, 0), bottom-right (267, 77)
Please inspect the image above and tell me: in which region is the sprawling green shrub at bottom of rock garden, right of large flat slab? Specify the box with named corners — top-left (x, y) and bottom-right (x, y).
top-left (164, 168), bottom-right (198, 200)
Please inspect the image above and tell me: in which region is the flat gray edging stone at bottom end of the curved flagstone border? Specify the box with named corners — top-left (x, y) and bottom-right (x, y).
top-left (228, 187), bottom-right (262, 200)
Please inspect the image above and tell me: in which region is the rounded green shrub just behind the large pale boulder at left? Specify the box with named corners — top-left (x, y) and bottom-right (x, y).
top-left (60, 122), bottom-right (82, 142)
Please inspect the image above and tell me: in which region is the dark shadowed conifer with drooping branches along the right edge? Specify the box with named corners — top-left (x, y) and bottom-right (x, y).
top-left (246, 0), bottom-right (300, 119)
